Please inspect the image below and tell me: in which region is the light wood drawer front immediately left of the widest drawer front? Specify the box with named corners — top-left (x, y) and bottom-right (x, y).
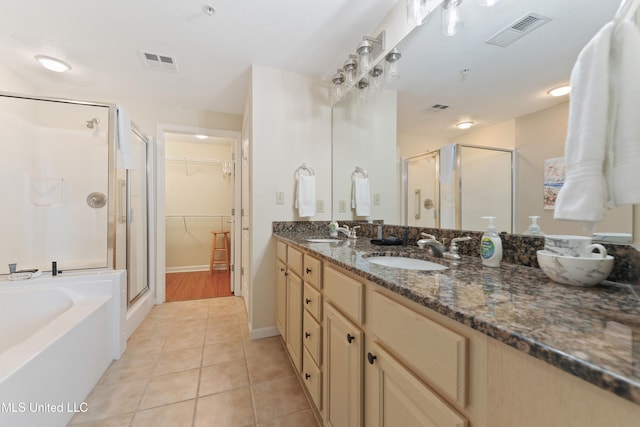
top-left (324, 267), bottom-right (364, 324)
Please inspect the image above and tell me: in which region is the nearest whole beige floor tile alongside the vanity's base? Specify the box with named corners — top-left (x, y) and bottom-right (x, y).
top-left (251, 377), bottom-right (309, 422)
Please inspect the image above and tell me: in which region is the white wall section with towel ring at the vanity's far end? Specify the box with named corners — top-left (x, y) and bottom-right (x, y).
top-left (249, 66), bottom-right (331, 337)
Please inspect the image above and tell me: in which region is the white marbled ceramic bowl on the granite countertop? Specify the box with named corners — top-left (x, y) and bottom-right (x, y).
top-left (537, 251), bottom-right (613, 286)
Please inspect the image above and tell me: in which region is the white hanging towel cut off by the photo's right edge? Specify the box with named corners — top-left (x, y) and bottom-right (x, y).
top-left (605, 20), bottom-right (640, 207)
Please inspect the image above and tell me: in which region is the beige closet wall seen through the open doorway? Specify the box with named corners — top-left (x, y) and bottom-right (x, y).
top-left (165, 138), bottom-right (234, 272)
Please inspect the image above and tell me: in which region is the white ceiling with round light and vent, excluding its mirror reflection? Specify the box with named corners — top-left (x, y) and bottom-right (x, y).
top-left (0, 0), bottom-right (397, 114)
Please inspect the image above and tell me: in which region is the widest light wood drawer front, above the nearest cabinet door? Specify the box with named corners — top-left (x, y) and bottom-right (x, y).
top-left (367, 292), bottom-right (468, 407)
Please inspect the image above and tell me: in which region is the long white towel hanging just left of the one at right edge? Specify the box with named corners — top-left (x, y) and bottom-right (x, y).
top-left (554, 23), bottom-right (614, 222)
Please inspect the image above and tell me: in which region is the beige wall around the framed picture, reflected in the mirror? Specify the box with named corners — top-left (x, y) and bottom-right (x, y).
top-left (514, 102), bottom-right (632, 235)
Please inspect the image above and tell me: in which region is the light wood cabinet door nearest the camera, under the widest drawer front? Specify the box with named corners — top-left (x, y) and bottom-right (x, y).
top-left (365, 344), bottom-right (468, 427)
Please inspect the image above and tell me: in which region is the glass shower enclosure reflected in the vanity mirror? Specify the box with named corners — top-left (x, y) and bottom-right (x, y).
top-left (402, 144), bottom-right (514, 232)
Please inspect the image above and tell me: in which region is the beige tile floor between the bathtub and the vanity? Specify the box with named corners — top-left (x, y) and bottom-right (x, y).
top-left (69, 297), bottom-right (319, 427)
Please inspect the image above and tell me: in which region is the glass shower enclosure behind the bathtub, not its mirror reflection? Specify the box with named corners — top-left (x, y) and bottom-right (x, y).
top-left (0, 93), bottom-right (149, 305)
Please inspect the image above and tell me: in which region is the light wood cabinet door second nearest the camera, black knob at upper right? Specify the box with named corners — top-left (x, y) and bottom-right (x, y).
top-left (324, 304), bottom-right (364, 427)
